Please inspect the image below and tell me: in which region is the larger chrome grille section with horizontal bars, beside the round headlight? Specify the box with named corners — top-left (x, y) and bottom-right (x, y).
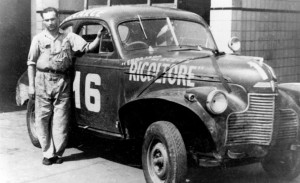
top-left (225, 94), bottom-right (275, 146)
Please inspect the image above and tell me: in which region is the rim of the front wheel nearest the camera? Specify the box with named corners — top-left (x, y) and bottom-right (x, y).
top-left (147, 141), bottom-right (169, 182)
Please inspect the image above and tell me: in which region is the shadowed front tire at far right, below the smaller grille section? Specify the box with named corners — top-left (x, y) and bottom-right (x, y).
top-left (261, 150), bottom-right (300, 180)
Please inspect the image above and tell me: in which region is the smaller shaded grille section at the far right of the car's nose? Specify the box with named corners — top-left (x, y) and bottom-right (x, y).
top-left (275, 109), bottom-right (299, 141)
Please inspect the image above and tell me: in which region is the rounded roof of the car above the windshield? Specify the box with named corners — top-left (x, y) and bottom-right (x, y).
top-left (62, 5), bottom-right (203, 24)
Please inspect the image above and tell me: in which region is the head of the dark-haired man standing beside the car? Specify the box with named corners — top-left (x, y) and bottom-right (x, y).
top-left (41, 7), bottom-right (59, 31)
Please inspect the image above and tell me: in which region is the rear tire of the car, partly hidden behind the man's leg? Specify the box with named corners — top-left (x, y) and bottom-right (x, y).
top-left (26, 100), bottom-right (41, 148)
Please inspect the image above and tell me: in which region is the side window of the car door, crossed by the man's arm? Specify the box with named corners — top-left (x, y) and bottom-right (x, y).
top-left (78, 23), bottom-right (114, 54)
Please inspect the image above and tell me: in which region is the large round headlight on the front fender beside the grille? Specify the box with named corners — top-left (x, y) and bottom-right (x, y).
top-left (206, 90), bottom-right (228, 114)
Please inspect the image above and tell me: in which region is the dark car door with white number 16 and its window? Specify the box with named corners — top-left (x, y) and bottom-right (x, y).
top-left (73, 20), bottom-right (121, 135)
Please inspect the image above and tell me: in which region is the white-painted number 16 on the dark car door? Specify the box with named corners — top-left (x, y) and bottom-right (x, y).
top-left (73, 71), bottom-right (101, 112)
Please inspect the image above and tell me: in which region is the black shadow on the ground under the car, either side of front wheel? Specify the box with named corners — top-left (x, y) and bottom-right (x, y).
top-left (65, 134), bottom-right (289, 183)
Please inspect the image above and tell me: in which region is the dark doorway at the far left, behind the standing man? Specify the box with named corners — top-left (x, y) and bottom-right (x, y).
top-left (0, 0), bottom-right (31, 112)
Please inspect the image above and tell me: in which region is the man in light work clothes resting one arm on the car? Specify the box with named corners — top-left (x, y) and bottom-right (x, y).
top-left (27, 7), bottom-right (103, 165)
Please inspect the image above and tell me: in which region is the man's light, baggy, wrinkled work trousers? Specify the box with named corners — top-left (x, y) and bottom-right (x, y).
top-left (35, 71), bottom-right (71, 158)
